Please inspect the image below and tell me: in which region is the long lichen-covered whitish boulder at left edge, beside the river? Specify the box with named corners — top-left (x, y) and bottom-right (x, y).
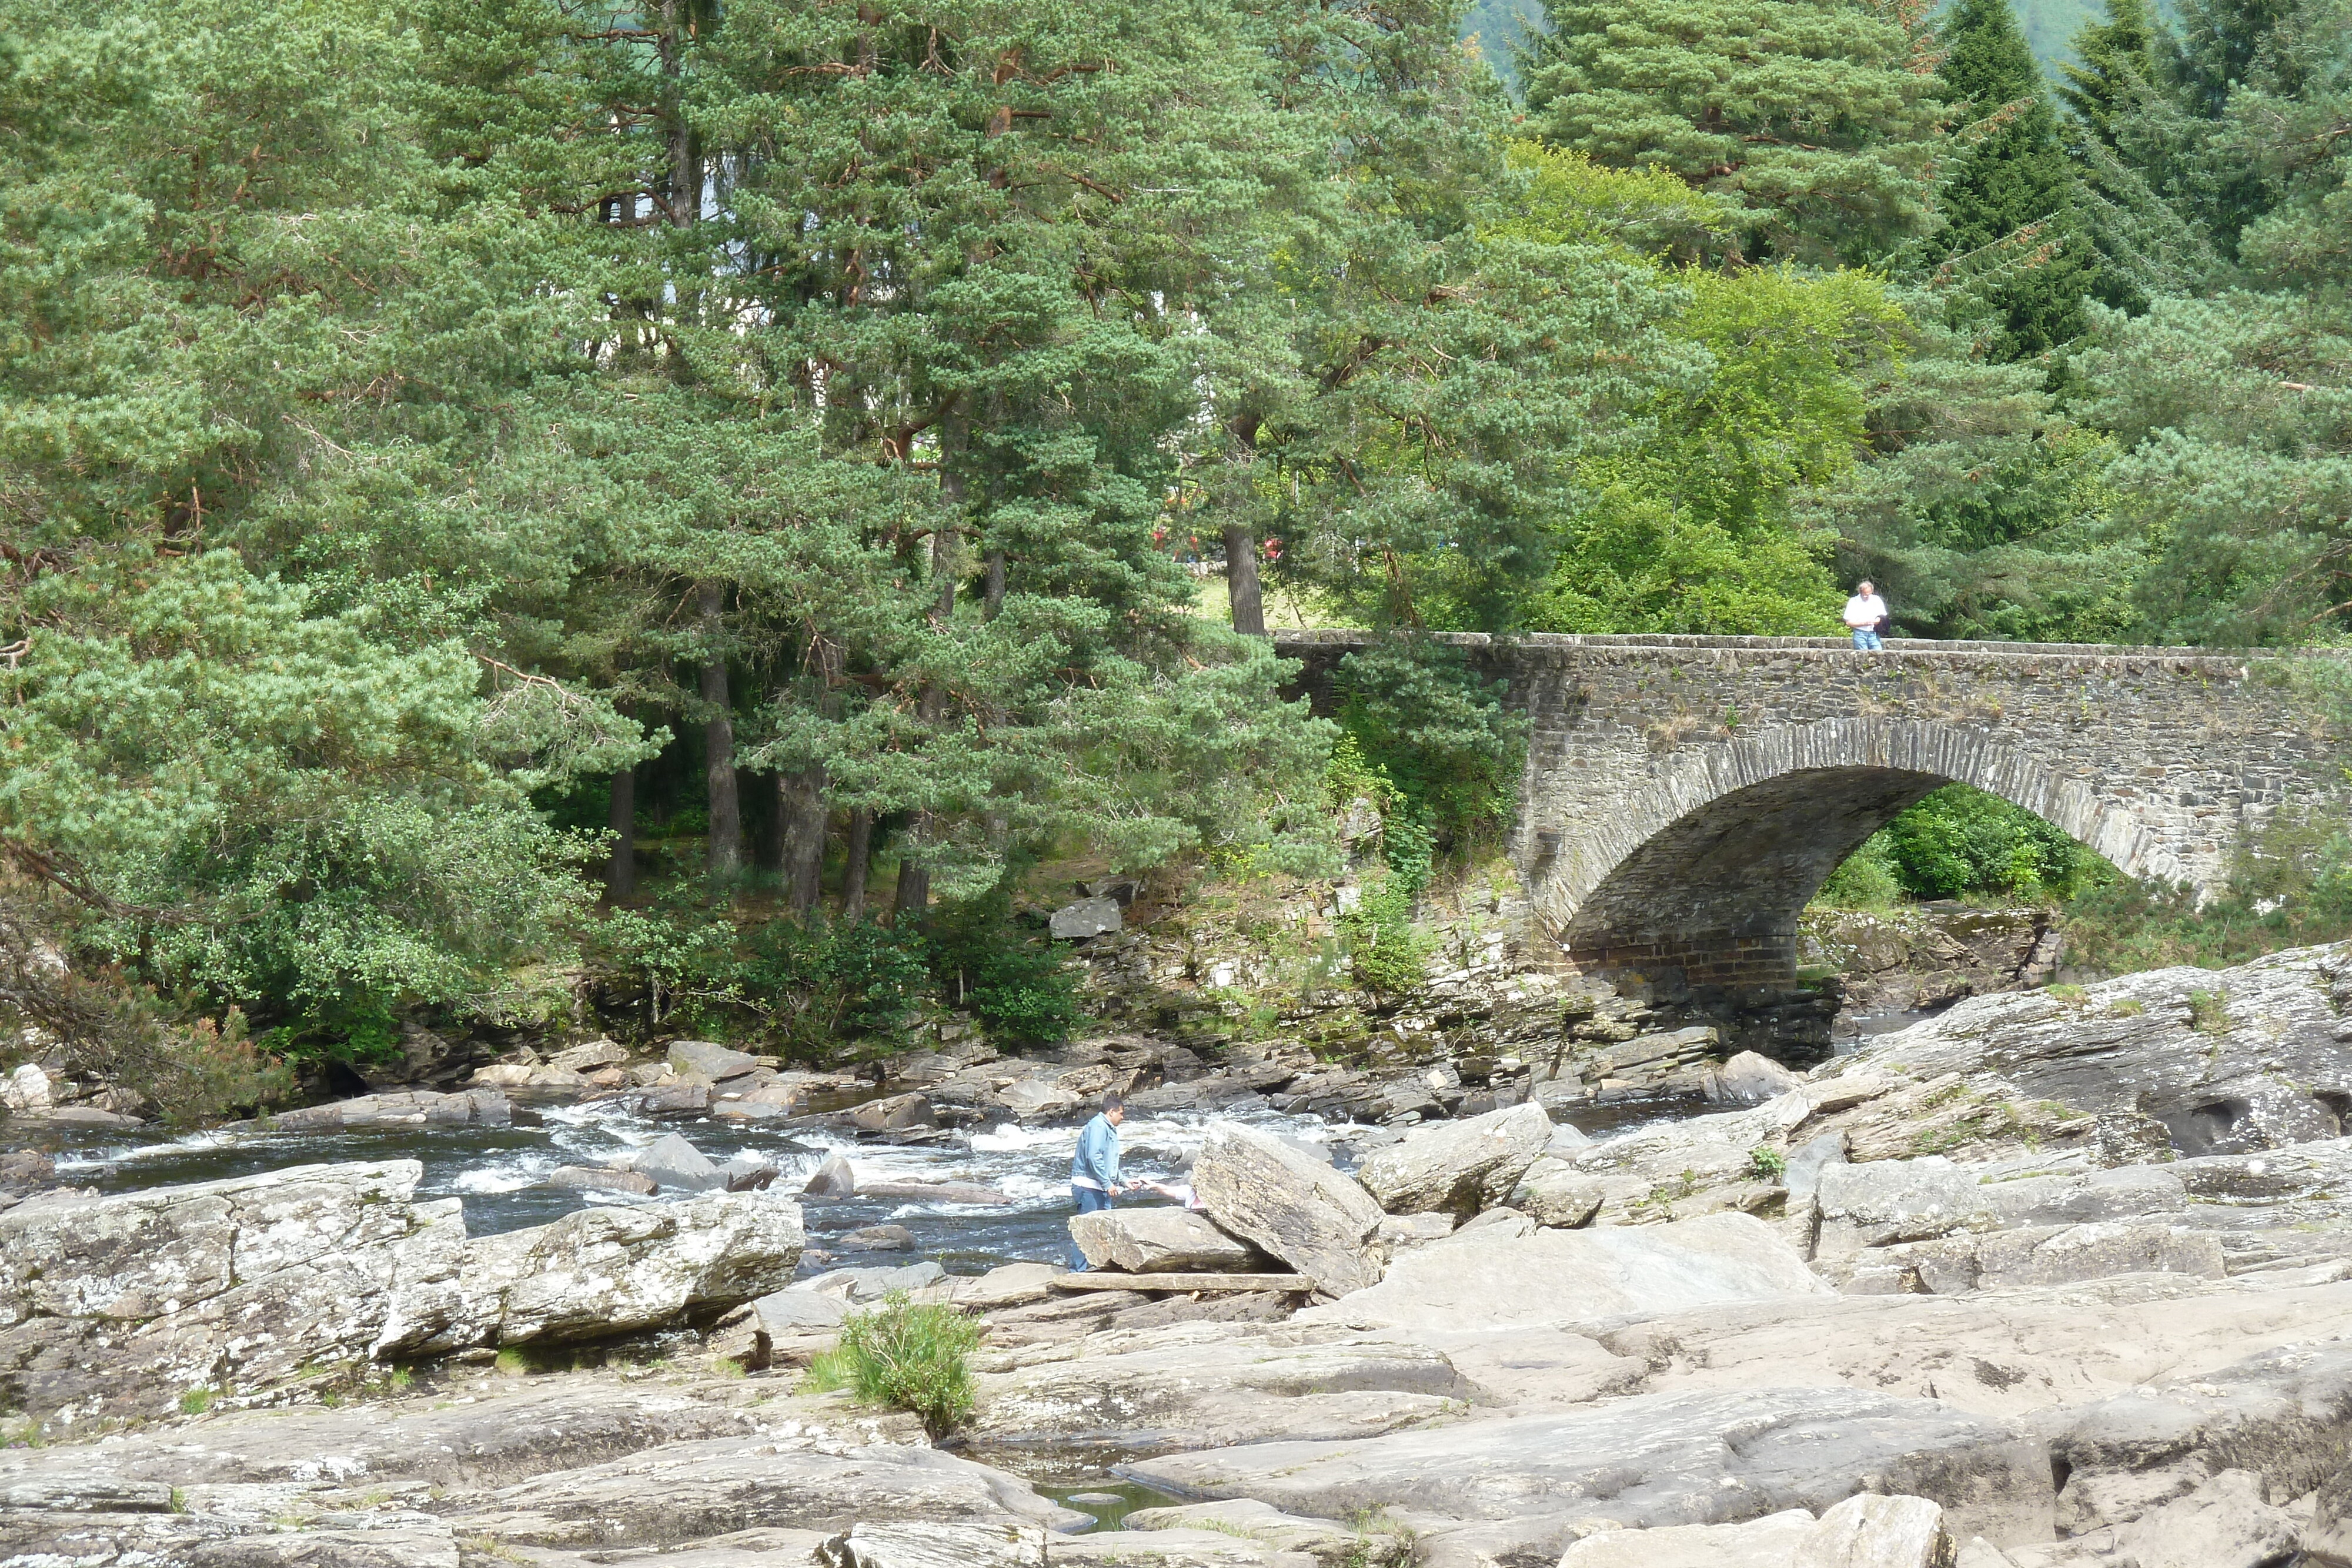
top-left (0, 1159), bottom-right (802, 1420)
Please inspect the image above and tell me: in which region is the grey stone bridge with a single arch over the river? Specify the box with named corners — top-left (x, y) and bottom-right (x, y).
top-left (1275, 633), bottom-right (2321, 987)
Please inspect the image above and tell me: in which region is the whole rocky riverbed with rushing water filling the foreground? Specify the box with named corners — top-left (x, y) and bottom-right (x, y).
top-left (0, 947), bottom-right (2352, 1568)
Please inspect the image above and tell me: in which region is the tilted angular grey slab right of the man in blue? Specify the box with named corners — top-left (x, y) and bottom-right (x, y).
top-left (1192, 1124), bottom-right (1381, 1295)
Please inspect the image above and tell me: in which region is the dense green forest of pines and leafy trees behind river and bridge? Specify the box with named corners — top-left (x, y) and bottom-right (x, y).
top-left (0, 0), bottom-right (2352, 1109)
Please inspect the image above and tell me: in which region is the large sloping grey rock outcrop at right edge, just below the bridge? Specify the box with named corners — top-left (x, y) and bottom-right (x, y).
top-left (1837, 945), bottom-right (2352, 1154)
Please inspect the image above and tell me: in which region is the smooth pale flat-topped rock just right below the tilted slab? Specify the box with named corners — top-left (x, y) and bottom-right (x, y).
top-left (1298, 1213), bottom-right (1832, 1328)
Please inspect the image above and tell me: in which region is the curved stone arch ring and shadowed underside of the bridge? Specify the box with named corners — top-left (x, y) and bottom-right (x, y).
top-left (1529, 717), bottom-right (2194, 982)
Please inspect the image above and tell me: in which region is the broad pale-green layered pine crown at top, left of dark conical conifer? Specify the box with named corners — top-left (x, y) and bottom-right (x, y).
top-left (1524, 0), bottom-right (1943, 263)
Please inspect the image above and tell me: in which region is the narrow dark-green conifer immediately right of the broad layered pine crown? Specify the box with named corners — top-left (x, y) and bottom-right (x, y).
top-left (1931, 0), bottom-right (2098, 360)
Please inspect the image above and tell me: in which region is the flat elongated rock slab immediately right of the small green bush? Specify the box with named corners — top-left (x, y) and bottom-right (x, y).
top-left (969, 1323), bottom-right (1470, 1453)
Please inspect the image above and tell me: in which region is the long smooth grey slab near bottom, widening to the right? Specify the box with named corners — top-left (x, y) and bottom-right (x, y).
top-left (1124, 1387), bottom-right (2056, 1549)
